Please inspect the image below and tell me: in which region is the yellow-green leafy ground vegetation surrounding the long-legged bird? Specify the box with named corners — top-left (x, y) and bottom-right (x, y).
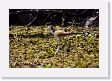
top-left (9, 26), bottom-right (99, 68)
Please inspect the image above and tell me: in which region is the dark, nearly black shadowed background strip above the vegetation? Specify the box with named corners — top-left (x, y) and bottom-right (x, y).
top-left (9, 9), bottom-right (99, 26)
